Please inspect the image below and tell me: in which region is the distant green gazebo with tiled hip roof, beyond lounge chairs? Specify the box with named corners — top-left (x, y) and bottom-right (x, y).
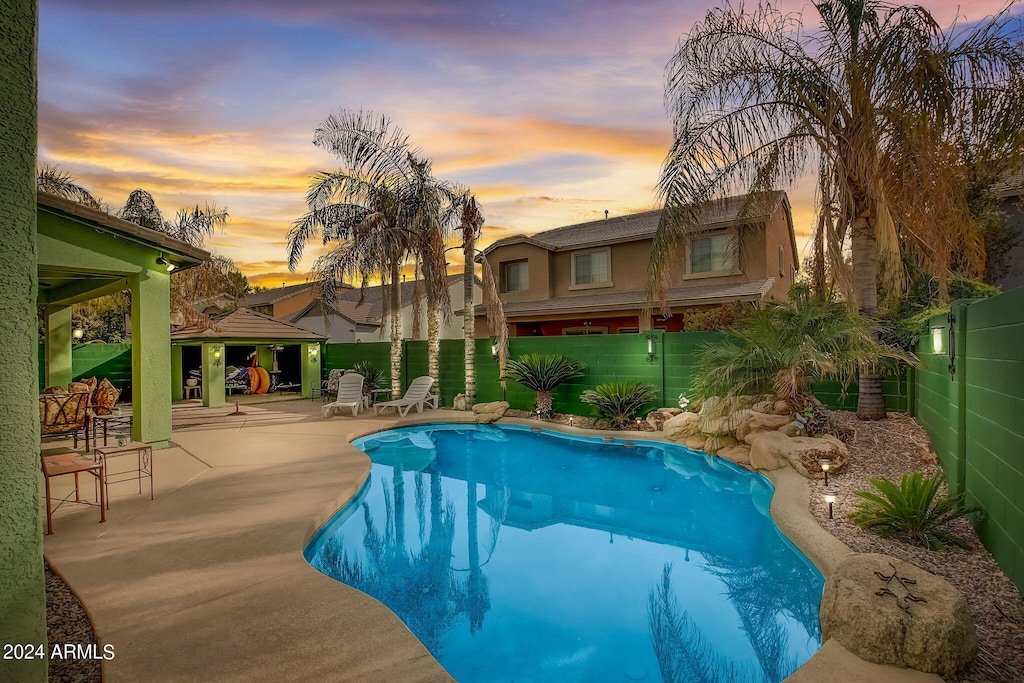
top-left (171, 307), bottom-right (327, 407)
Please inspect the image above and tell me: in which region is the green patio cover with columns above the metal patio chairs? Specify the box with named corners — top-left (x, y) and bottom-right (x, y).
top-left (36, 193), bottom-right (210, 447)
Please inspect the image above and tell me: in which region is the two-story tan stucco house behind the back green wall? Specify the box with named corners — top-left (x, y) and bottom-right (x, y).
top-left (484, 191), bottom-right (798, 337)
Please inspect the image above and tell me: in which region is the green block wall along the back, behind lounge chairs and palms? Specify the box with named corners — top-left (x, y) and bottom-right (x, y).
top-left (324, 330), bottom-right (907, 416)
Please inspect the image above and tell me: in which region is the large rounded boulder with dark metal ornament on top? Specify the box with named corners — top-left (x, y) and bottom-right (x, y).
top-left (820, 554), bottom-right (978, 677)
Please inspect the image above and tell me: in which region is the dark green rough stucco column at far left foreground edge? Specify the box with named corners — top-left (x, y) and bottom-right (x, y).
top-left (0, 0), bottom-right (46, 683)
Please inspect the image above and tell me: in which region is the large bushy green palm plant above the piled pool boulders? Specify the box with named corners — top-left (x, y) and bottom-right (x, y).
top-left (693, 288), bottom-right (916, 431)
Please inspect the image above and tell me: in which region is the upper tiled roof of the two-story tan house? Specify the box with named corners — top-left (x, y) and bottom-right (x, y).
top-left (483, 190), bottom-right (796, 254)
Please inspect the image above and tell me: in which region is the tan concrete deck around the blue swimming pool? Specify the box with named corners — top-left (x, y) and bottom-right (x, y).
top-left (44, 401), bottom-right (941, 683)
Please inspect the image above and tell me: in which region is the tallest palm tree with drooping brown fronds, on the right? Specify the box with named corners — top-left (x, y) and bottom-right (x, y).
top-left (648, 0), bottom-right (1024, 419)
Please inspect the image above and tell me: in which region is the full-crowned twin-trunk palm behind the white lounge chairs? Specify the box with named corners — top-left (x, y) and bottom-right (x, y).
top-left (288, 111), bottom-right (460, 393)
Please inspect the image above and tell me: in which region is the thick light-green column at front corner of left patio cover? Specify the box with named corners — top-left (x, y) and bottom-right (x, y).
top-left (128, 269), bottom-right (171, 449)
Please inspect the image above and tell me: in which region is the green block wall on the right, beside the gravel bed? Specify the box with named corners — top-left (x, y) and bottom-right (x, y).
top-left (914, 289), bottom-right (1024, 590)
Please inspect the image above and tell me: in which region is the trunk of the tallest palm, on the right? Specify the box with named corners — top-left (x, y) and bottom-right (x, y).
top-left (850, 214), bottom-right (886, 420)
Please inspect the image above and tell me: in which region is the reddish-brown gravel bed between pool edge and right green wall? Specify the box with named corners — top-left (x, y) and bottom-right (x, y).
top-left (810, 412), bottom-right (1024, 683)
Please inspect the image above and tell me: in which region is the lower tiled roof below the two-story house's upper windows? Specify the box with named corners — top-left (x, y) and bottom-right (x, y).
top-left (495, 278), bottom-right (775, 317)
